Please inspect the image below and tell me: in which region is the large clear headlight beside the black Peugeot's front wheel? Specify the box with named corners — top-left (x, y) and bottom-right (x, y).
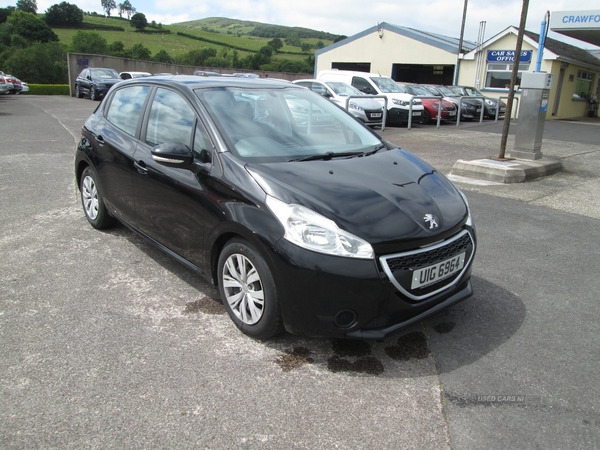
top-left (267, 195), bottom-right (374, 259)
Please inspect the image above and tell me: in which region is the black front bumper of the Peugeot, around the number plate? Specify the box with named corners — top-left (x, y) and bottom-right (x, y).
top-left (269, 229), bottom-right (476, 339)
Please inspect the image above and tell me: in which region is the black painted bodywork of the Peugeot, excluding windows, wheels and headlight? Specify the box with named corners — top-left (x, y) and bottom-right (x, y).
top-left (75, 76), bottom-right (475, 338)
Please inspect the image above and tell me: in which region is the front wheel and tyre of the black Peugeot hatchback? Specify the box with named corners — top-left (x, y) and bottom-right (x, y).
top-left (218, 239), bottom-right (283, 339)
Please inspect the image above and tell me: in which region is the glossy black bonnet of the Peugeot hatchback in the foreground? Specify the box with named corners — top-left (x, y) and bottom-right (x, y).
top-left (246, 149), bottom-right (467, 244)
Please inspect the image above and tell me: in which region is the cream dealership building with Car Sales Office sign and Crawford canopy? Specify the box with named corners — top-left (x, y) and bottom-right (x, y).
top-left (315, 10), bottom-right (600, 119)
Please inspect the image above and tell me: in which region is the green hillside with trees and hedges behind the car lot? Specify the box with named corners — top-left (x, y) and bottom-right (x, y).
top-left (0, 11), bottom-right (339, 84)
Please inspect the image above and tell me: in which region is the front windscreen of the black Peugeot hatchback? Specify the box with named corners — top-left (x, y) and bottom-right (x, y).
top-left (196, 87), bottom-right (381, 162)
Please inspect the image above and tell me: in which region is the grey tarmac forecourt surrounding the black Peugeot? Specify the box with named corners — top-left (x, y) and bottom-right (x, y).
top-left (0, 96), bottom-right (600, 450)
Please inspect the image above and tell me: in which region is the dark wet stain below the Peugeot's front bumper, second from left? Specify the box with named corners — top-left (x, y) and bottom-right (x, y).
top-left (327, 339), bottom-right (385, 375)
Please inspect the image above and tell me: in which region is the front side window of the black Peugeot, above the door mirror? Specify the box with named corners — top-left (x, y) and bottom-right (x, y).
top-left (146, 88), bottom-right (196, 147)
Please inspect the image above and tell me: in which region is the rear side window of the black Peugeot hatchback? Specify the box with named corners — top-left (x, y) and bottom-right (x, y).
top-left (106, 86), bottom-right (150, 137)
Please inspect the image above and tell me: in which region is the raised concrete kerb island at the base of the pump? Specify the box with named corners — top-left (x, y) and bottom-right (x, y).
top-left (451, 157), bottom-right (563, 183)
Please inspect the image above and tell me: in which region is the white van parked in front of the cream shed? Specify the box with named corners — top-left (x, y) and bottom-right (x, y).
top-left (317, 70), bottom-right (423, 125)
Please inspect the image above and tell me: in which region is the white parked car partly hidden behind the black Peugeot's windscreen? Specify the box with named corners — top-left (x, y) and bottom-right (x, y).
top-left (293, 80), bottom-right (383, 126)
